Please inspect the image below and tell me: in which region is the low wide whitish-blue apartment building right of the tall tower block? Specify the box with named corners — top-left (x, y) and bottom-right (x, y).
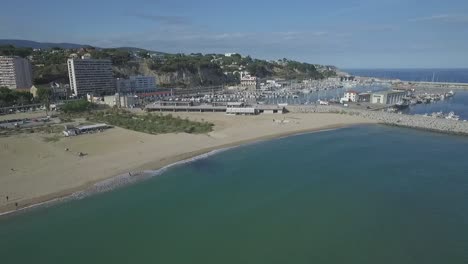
top-left (116, 76), bottom-right (156, 94)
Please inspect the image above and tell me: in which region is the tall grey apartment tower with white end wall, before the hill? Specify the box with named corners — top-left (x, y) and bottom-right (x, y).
top-left (67, 59), bottom-right (115, 96)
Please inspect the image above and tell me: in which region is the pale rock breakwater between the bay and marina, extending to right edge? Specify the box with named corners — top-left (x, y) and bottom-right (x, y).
top-left (287, 105), bottom-right (468, 136)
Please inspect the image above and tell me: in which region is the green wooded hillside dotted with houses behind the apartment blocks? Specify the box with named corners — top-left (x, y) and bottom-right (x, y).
top-left (0, 40), bottom-right (337, 87)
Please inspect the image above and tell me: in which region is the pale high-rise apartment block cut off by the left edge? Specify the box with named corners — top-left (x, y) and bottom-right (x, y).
top-left (0, 56), bottom-right (33, 89)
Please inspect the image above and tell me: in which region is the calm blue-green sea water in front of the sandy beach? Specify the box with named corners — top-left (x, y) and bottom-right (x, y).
top-left (0, 126), bottom-right (468, 264)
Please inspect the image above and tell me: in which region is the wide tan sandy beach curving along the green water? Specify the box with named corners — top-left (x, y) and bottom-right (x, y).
top-left (0, 113), bottom-right (375, 212)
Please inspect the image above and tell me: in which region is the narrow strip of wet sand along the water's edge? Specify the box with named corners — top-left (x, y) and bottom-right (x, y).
top-left (0, 122), bottom-right (358, 218)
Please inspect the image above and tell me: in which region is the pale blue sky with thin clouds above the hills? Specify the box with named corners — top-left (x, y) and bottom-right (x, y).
top-left (0, 0), bottom-right (468, 69)
